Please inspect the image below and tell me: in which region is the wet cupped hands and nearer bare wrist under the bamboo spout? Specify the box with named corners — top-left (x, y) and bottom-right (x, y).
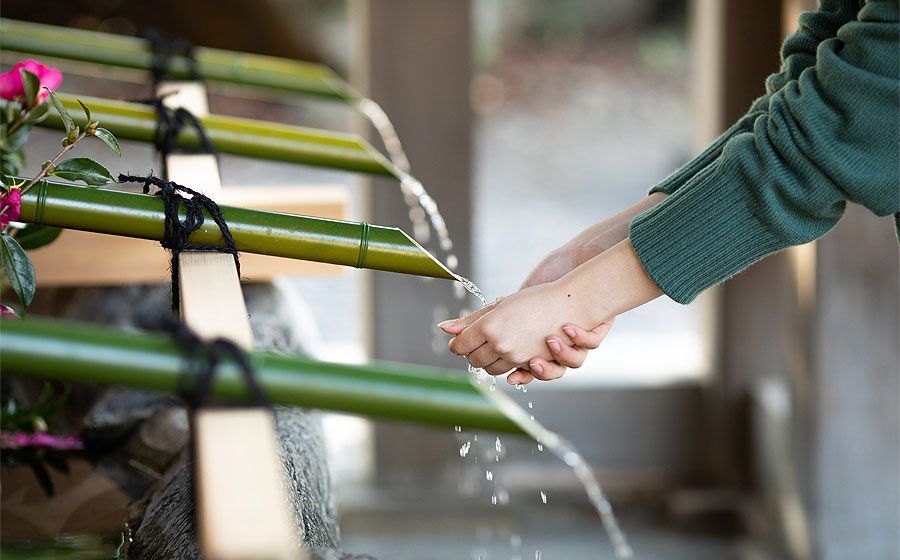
top-left (439, 239), bottom-right (661, 383)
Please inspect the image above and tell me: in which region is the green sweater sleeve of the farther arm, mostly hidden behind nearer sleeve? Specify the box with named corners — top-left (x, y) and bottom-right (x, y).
top-left (650, 0), bottom-right (859, 194)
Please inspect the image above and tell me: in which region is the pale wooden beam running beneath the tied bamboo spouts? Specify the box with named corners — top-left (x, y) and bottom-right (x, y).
top-left (157, 82), bottom-right (305, 560)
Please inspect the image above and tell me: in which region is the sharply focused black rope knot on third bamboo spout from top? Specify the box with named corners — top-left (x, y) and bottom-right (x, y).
top-left (119, 174), bottom-right (241, 314)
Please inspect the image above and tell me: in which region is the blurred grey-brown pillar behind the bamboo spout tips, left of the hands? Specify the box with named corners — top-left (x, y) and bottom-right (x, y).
top-left (351, 0), bottom-right (472, 481)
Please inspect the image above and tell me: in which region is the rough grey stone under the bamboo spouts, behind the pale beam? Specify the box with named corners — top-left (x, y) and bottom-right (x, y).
top-left (30, 284), bottom-right (370, 560)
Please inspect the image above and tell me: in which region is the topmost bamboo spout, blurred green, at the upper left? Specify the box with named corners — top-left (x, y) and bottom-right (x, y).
top-left (0, 19), bottom-right (358, 100)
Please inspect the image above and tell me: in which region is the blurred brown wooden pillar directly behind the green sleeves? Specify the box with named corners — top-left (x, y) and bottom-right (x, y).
top-left (692, 0), bottom-right (793, 485)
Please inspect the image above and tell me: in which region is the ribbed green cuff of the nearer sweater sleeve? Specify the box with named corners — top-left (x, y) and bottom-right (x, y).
top-left (629, 162), bottom-right (782, 303)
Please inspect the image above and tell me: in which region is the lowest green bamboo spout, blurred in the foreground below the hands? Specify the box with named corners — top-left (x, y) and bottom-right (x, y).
top-left (0, 318), bottom-right (521, 433)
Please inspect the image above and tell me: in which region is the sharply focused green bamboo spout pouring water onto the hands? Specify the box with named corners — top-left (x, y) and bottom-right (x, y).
top-left (16, 178), bottom-right (458, 280)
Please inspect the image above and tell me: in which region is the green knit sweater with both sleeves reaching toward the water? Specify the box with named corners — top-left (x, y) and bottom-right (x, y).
top-left (629, 0), bottom-right (900, 303)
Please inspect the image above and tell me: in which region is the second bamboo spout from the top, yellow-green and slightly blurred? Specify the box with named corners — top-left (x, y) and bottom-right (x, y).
top-left (40, 93), bottom-right (395, 176)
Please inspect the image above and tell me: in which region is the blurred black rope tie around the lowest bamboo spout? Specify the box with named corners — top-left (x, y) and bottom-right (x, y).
top-left (169, 323), bottom-right (271, 408)
